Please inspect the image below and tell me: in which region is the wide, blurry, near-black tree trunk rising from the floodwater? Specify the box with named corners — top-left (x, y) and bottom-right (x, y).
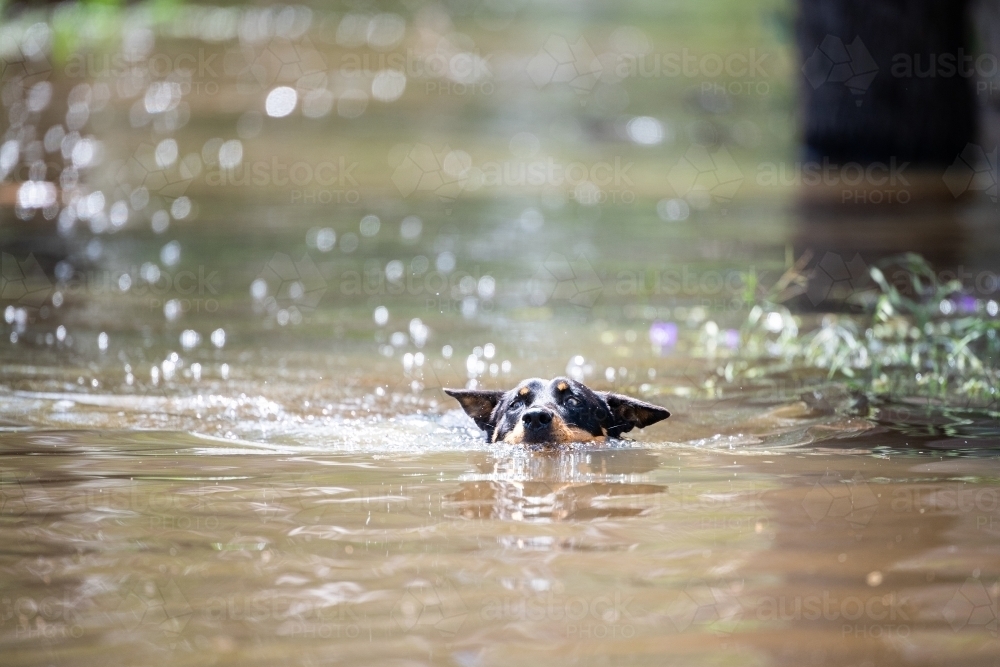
top-left (796, 0), bottom-right (977, 168)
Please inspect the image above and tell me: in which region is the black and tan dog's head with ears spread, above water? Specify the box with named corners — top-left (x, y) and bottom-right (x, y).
top-left (444, 378), bottom-right (670, 444)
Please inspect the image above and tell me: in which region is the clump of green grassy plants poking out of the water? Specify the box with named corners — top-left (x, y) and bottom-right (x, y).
top-left (726, 253), bottom-right (1000, 408)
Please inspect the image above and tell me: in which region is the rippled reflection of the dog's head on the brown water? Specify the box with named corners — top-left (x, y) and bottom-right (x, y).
top-left (446, 449), bottom-right (667, 522)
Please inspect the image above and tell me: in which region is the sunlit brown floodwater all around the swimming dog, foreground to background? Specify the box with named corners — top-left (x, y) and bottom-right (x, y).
top-left (0, 2), bottom-right (1000, 667)
